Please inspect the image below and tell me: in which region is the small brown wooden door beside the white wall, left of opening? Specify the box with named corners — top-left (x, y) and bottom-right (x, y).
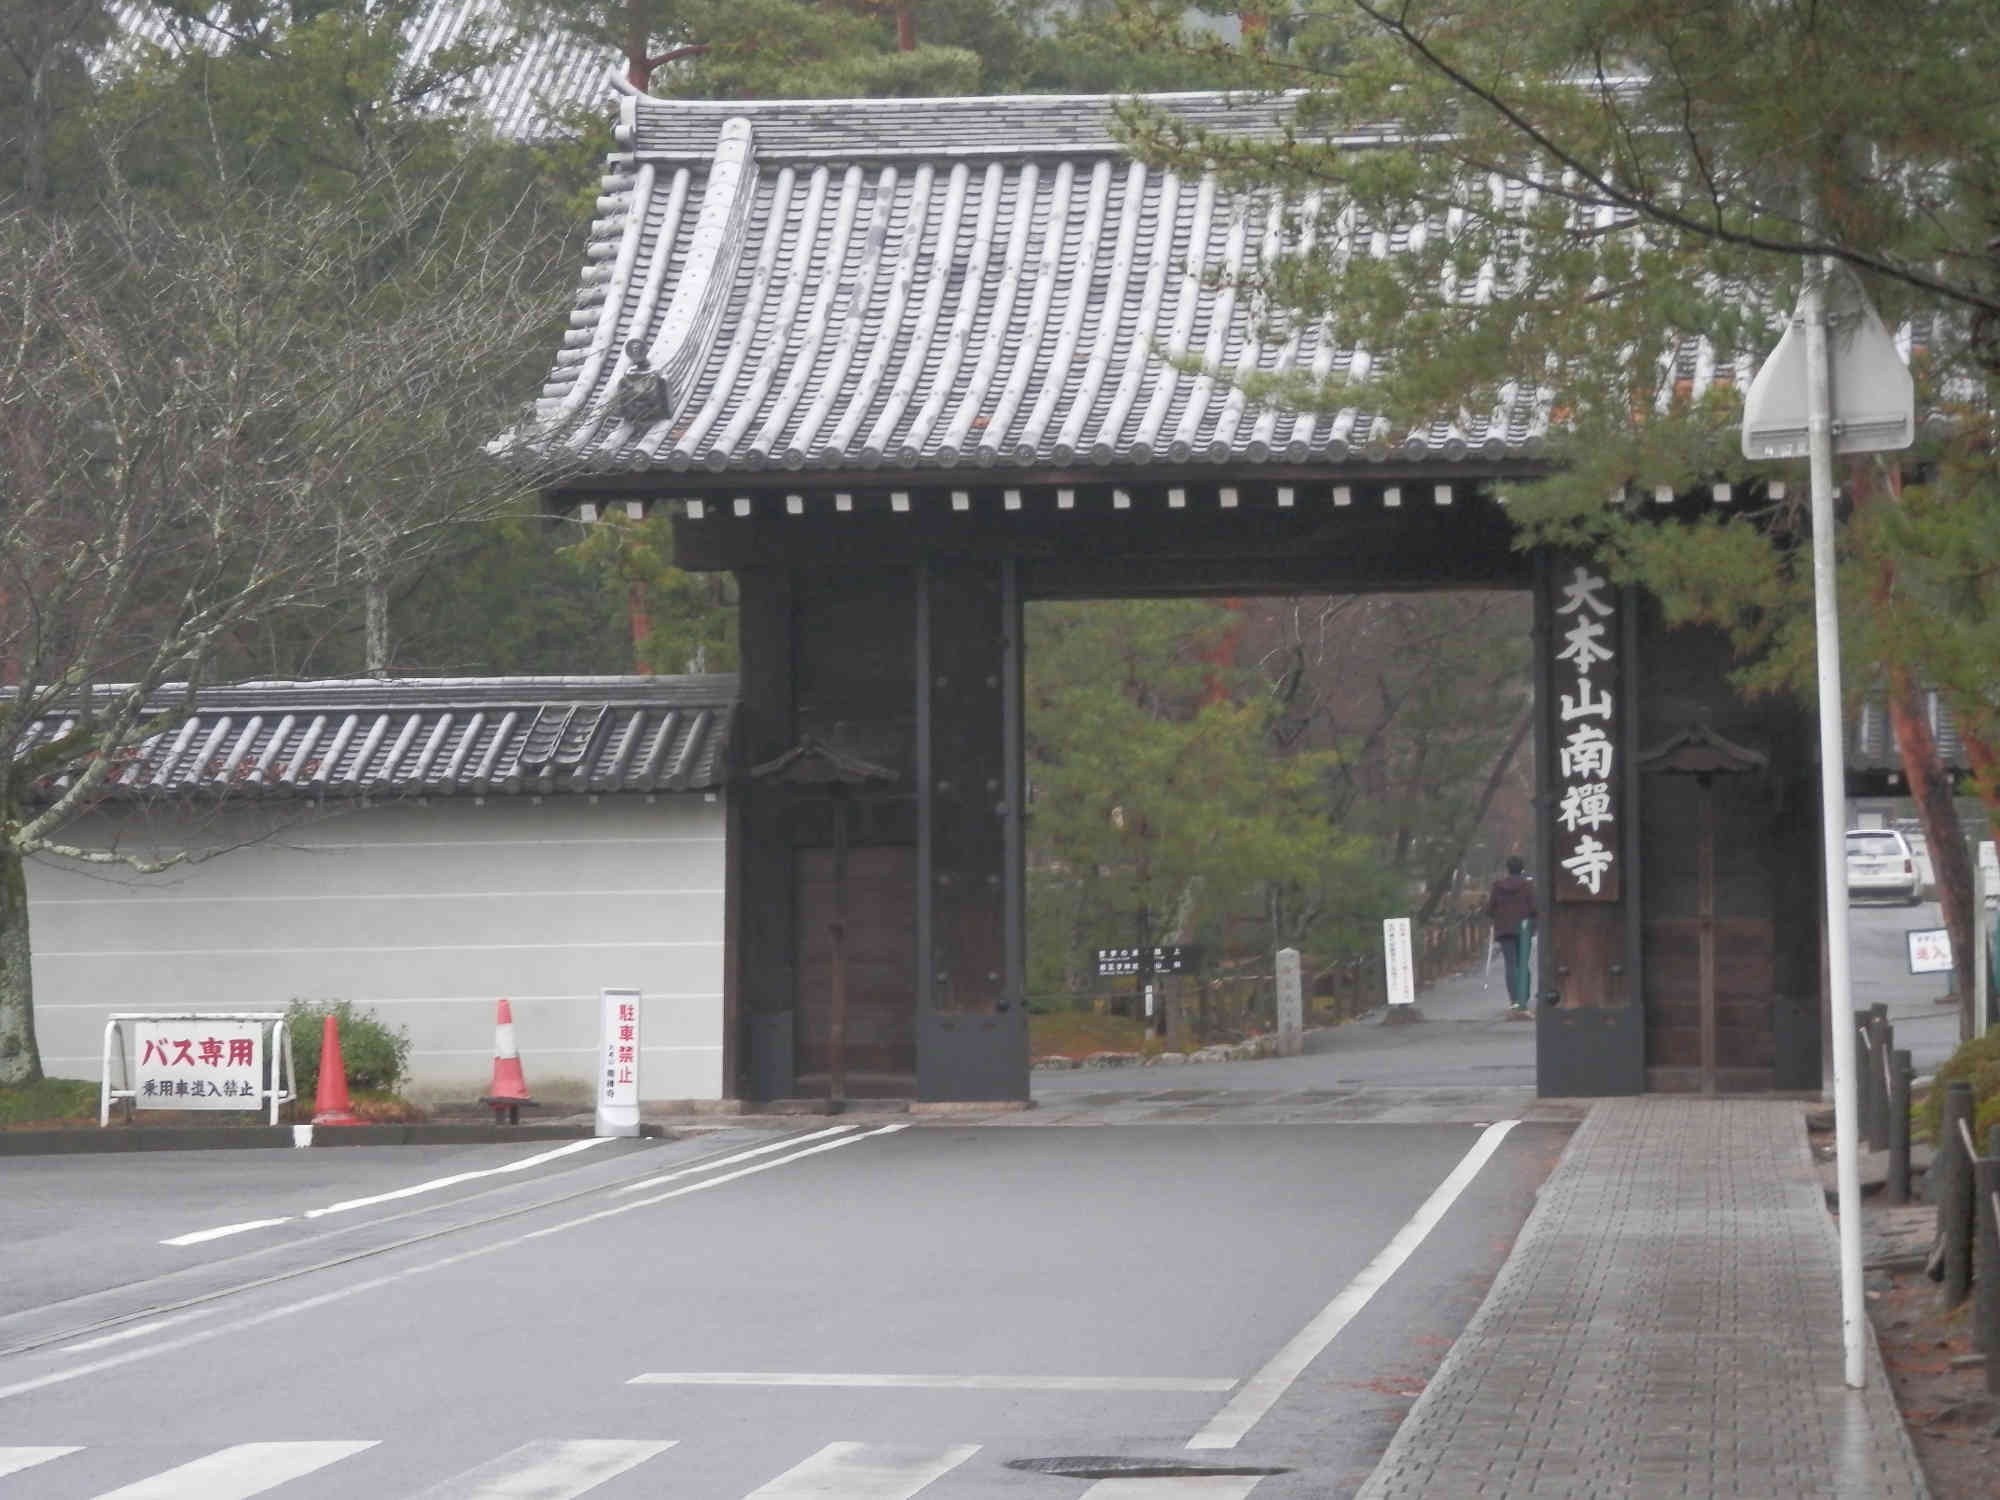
top-left (794, 844), bottom-right (916, 1098)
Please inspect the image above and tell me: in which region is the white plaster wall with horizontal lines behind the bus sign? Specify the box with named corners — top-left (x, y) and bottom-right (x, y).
top-left (28, 794), bottom-right (724, 1104)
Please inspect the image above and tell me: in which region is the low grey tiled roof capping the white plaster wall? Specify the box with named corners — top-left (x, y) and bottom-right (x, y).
top-left (22, 676), bottom-right (736, 798)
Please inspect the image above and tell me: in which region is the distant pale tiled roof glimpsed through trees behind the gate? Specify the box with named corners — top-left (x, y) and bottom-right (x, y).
top-left (112, 0), bottom-right (618, 140)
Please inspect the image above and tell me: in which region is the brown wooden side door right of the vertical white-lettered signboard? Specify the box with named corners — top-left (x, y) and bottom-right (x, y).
top-left (1640, 772), bottom-right (1776, 1094)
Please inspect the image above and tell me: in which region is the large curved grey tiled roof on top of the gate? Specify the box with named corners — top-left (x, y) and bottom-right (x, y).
top-left (536, 94), bottom-right (1548, 474)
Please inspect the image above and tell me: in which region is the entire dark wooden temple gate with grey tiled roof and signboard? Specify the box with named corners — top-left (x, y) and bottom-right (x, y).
top-left (530, 94), bottom-right (1820, 1100)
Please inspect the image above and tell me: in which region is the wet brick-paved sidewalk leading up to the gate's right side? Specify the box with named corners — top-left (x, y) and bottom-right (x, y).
top-left (1358, 1096), bottom-right (1926, 1500)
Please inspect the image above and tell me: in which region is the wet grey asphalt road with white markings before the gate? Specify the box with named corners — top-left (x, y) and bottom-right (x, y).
top-left (0, 1120), bottom-right (1566, 1500)
